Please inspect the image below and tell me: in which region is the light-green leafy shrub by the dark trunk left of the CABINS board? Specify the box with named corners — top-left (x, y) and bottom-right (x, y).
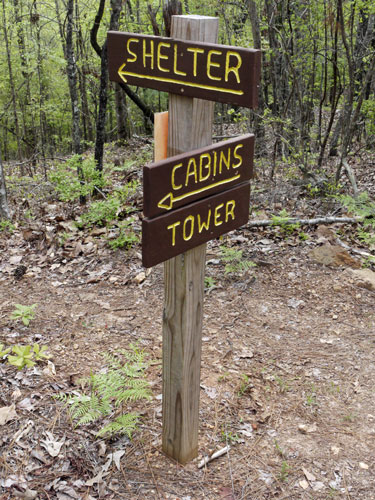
top-left (48, 155), bottom-right (106, 201)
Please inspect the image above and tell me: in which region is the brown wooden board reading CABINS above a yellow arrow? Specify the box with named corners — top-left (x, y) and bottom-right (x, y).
top-left (143, 134), bottom-right (254, 218)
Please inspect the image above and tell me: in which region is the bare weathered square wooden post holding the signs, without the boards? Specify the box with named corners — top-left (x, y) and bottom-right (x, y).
top-left (163, 16), bottom-right (219, 464)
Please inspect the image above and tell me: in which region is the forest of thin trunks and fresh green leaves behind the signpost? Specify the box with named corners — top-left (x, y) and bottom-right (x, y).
top-left (0, 0), bottom-right (375, 222)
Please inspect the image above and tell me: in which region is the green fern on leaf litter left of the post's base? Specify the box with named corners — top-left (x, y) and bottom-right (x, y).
top-left (56, 344), bottom-right (151, 438)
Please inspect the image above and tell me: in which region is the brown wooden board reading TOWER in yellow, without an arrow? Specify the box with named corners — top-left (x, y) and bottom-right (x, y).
top-left (142, 182), bottom-right (250, 267)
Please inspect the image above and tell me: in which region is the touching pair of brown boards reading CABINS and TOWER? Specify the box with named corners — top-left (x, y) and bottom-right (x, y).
top-left (142, 134), bottom-right (254, 267)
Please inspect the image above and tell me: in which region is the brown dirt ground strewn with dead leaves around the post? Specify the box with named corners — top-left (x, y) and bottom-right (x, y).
top-left (0, 146), bottom-right (375, 500)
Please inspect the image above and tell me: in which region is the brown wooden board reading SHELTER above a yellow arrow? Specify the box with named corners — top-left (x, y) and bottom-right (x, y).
top-left (107, 31), bottom-right (261, 108)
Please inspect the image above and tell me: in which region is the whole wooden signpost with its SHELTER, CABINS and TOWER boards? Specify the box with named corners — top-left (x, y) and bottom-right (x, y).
top-left (108, 16), bottom-right (260, 464)
